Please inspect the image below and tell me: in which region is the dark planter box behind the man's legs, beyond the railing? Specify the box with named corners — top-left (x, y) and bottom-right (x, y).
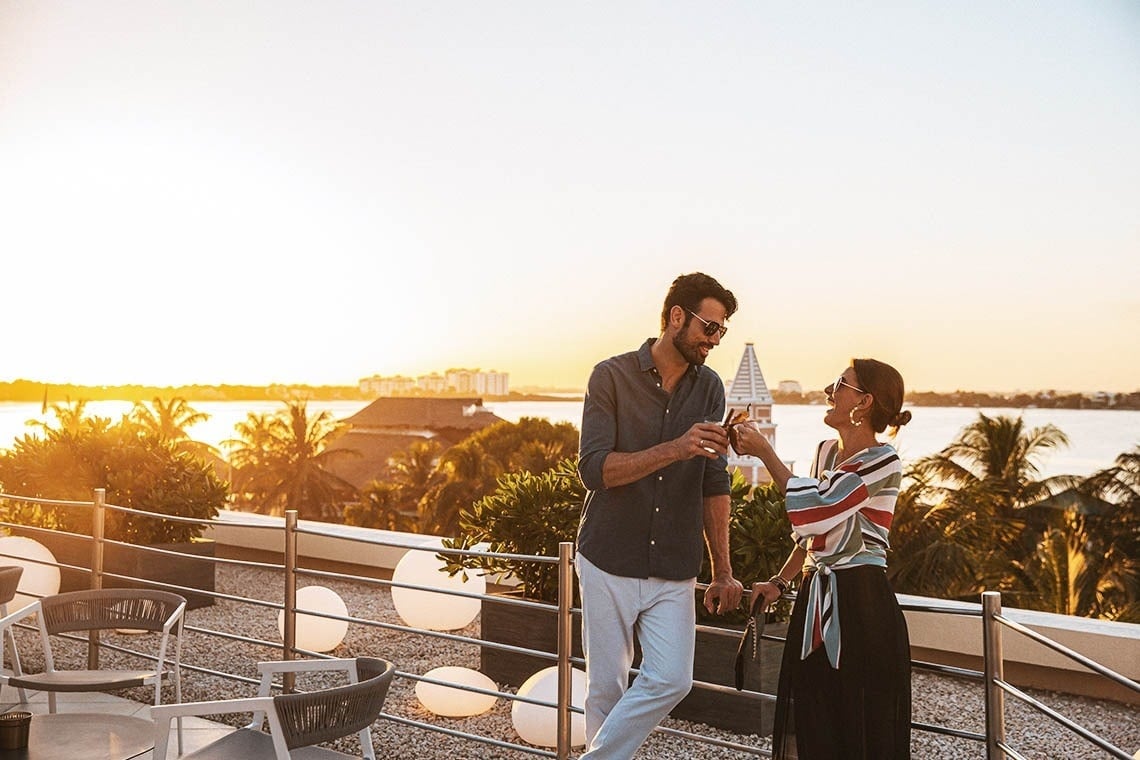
top-left (480, 599), bottom-right (785, 736)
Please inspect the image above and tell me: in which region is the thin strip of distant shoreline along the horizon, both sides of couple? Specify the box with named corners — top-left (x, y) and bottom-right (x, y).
top-left (0, 379), bottom-right (1140, 410)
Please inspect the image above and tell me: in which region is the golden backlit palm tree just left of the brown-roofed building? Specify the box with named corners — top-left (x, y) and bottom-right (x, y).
top-left (227, 401), bottom-right (357, 522)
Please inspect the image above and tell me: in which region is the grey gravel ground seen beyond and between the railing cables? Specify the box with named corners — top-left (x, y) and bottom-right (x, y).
top-left (18, 565), bottom-right (1140, 760)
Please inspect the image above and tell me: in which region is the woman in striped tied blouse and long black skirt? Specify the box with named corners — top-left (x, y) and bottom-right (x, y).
top-left (732, 359), bottom-right (911, 760)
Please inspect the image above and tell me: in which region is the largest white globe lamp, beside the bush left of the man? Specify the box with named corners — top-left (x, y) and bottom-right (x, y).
top-left (392, 548), bottom-right (487, 631)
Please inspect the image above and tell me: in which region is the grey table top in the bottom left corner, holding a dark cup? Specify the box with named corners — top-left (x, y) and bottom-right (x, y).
top-left (0, 712), bottom-right (154, 760)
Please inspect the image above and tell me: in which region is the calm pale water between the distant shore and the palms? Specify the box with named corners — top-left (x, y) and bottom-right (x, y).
top-left (0, 401), bottom-right (1140, 475)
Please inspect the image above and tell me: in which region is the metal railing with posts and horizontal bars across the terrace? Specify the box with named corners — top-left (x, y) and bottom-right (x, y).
top-left (0, 489), bottom-right (1140, 760)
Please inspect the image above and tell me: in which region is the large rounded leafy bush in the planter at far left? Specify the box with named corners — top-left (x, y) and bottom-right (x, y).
top-left (0, 401), bottom-right (227, 544)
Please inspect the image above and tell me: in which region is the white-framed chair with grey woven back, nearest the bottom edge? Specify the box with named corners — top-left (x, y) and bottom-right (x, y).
top-left (150, 657), bottom-right (396, 760)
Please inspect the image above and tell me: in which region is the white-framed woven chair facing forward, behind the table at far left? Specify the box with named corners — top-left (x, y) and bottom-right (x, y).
top-left (0, 589), bottom-right (186, 712)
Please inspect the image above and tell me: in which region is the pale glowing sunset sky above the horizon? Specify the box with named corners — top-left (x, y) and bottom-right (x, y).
top-left (0, 0), bottom-right (1140, 391)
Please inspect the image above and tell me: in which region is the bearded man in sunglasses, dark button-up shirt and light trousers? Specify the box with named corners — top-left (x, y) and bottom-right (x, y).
top-left (577, 272), bottom-right (743, 760)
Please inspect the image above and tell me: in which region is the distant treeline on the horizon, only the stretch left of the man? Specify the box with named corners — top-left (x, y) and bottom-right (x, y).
top-left (0, 379), bottom-right (571, 404)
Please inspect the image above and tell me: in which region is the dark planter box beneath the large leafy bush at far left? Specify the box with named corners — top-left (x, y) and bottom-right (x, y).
top-left (10, 528), bottom-right (214, 610)
